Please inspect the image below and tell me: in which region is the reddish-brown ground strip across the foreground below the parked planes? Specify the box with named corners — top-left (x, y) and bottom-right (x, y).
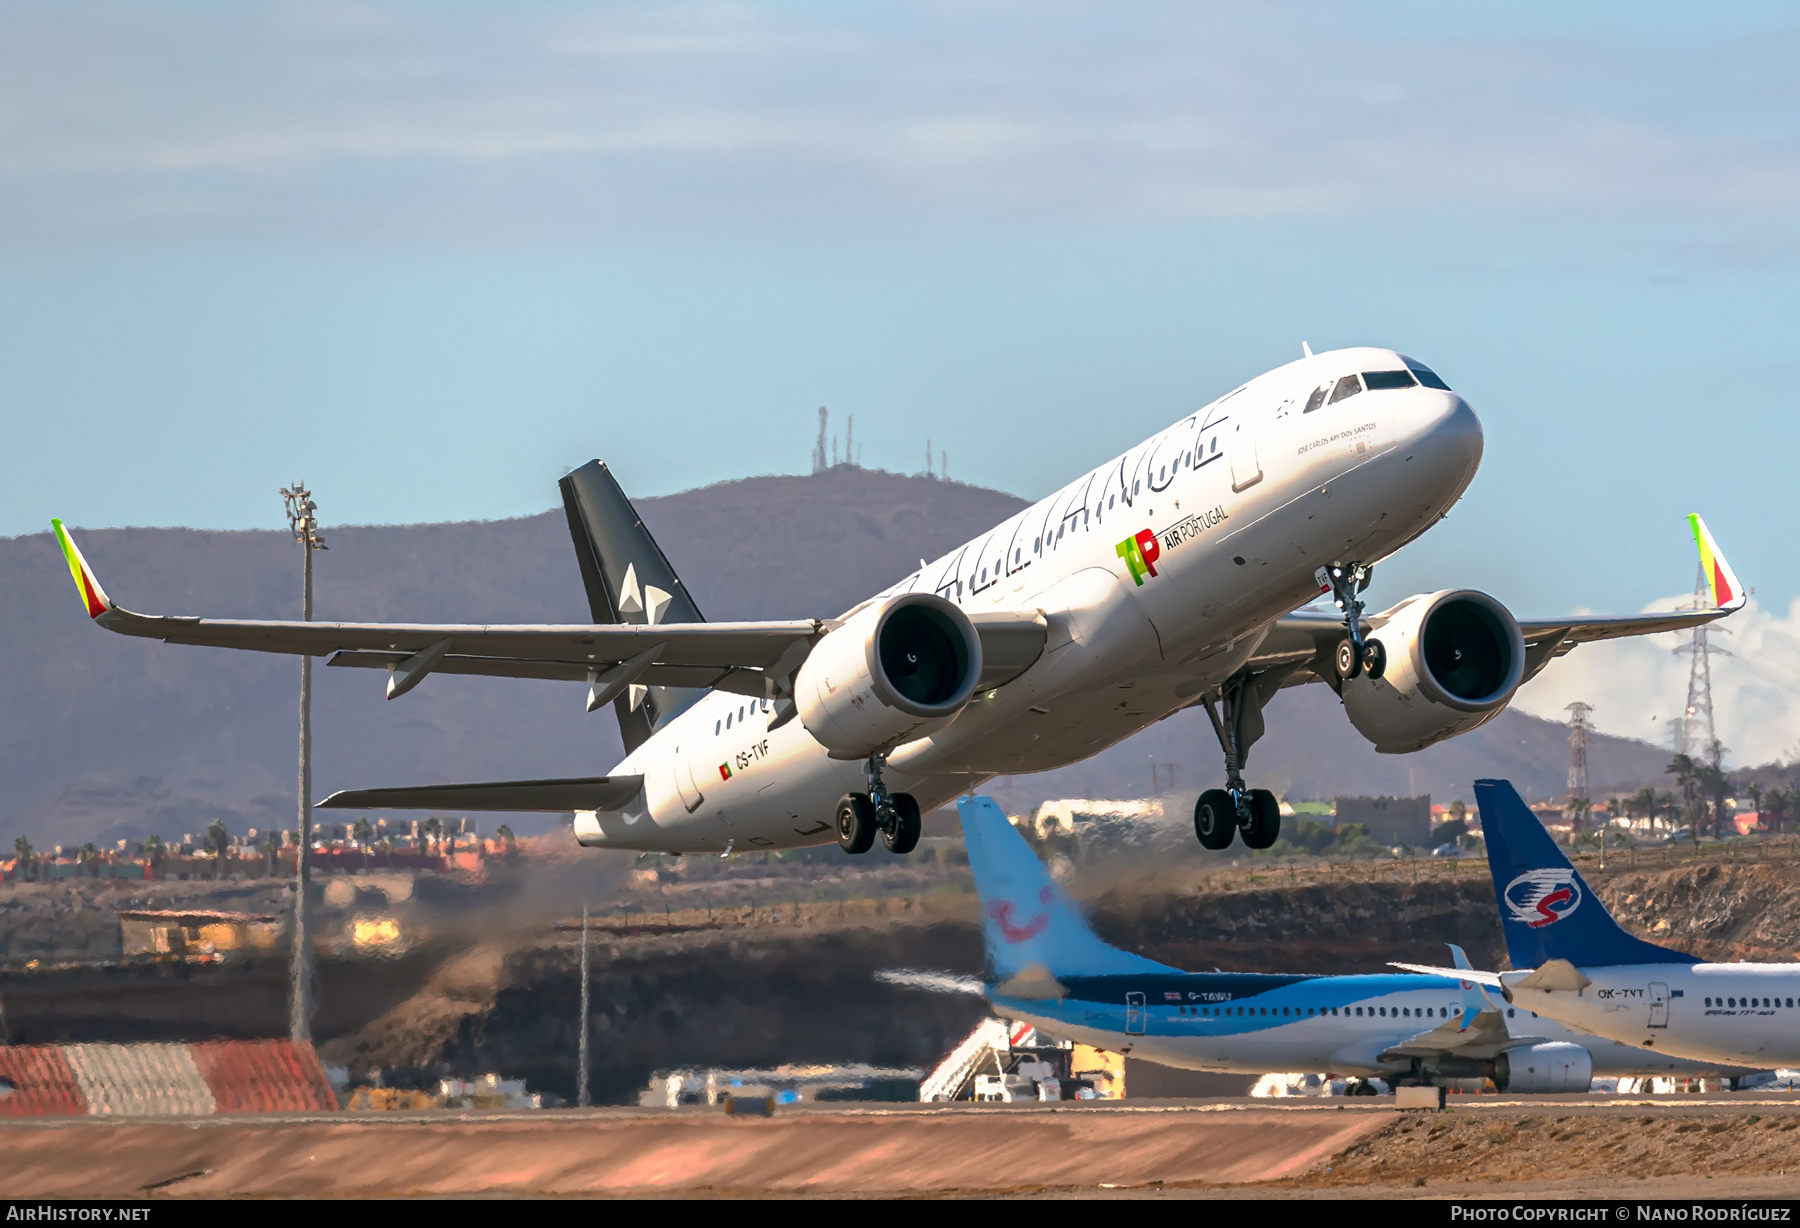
top-left (0, 1093), bottom-right (1800, 1197)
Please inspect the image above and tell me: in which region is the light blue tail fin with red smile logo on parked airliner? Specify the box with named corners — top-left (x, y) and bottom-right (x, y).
top-left (956, 798), bottom-right (1179, 981)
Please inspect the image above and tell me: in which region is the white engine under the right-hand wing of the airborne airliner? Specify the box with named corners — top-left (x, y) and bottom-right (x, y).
top-left (1339, 589), bottom-right (1525, 754)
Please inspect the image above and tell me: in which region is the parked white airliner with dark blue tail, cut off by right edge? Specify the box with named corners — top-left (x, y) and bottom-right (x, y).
top-left (1404, 780), bottom-right (1800, 1068)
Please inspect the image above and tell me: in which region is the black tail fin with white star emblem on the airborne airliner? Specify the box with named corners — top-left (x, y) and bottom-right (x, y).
top-left (558, 461), bottom-right (706, 751)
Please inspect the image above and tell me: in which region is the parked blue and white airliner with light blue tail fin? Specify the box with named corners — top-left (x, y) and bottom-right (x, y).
top-left (900, 796), bottom-right (1750, 1091)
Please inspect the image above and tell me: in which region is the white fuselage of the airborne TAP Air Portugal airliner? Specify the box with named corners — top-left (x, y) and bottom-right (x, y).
top-left (576, 351), bottom-right (1481, 852)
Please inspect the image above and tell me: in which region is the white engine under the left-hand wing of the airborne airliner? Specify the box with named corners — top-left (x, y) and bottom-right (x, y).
top-left (794, 592), bottom-right (981, 760)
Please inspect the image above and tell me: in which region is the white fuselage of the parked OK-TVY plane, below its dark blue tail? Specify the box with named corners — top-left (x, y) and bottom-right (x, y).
top-left (1512, 963), bottom-right (1800, 1070)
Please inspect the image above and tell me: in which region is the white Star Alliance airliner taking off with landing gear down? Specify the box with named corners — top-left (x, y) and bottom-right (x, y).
top-left (54, 349), bottom-right (1735, 853)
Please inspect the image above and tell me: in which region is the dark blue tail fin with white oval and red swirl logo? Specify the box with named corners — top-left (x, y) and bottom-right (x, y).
top-left (1474, 780), bottom-right (1699, 969)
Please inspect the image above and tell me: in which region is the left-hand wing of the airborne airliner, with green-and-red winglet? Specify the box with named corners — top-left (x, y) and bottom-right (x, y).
top-left (52, 520), bottom-right (1046, 698)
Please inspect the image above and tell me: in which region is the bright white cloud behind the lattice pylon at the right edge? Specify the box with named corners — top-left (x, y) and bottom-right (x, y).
top-left (1514, 598), bottom-right (1800, 767)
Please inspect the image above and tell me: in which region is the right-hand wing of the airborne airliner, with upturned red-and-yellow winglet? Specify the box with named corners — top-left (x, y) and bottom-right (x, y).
top-left (1246, 515), bottom-right (1746, 686)
